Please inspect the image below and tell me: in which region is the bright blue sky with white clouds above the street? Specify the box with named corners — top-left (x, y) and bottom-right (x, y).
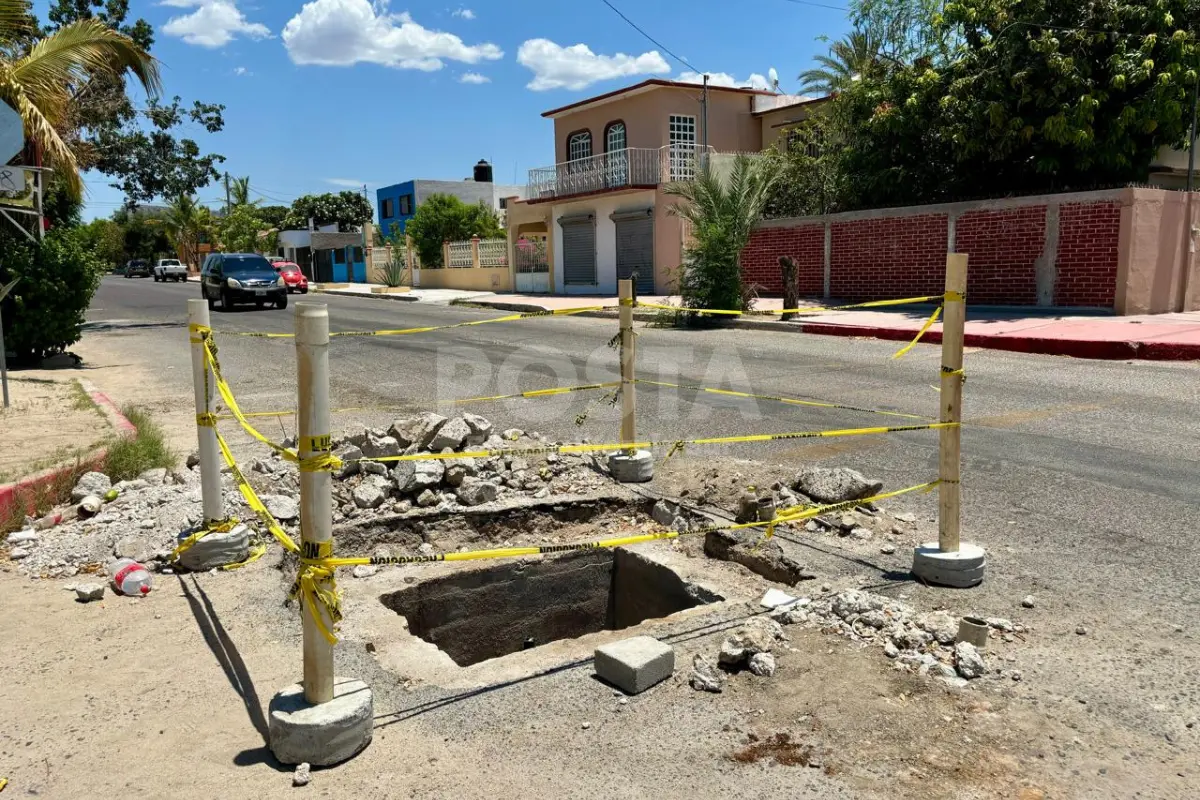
top-left (60, 0), bottom-right (848, 218)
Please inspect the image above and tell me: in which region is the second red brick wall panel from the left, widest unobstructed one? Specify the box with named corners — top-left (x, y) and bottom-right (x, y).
top-left (829, 213), bottom-right (948, 300)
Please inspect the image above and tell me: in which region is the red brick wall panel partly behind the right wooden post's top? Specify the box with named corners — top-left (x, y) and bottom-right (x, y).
top-left (954, 205), bottom-right (1046, 306)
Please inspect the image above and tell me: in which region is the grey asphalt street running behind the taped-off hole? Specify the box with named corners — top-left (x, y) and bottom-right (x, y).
top-left (84, 278), bottom-right (1200, 728)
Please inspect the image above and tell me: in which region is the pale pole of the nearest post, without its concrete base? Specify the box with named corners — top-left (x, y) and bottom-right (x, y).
top-left (295, 302), bottom-right (334, 703)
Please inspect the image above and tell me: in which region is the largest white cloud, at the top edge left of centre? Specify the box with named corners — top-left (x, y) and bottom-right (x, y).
top-left (283, 0), bottom-right (504, 72)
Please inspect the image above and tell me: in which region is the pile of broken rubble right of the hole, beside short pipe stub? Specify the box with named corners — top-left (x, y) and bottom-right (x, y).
top-left (691, 589), bottom-right (1026, 692)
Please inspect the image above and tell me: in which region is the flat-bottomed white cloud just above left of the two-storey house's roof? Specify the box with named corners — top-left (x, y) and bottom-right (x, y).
top-left (517, 38), bottom-right (671, 91)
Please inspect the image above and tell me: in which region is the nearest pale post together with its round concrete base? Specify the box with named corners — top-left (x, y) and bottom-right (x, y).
top-left (268, 302), bottom-right (374, 766)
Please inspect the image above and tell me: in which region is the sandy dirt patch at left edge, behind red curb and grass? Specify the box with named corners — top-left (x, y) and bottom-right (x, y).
top-left (0, 373), bottom-right (110, 483)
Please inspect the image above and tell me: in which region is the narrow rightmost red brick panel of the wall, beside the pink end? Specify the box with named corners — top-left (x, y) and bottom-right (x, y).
top-left (1054, 201), bottom-right (1121, 307)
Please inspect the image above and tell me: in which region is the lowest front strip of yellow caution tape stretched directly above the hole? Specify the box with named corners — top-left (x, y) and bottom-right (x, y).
top-left (304, 481), bottom-right (941, 573)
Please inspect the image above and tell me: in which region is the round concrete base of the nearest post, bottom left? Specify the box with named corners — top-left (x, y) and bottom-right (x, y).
top-left (268, 678), bottom-right (374, 766)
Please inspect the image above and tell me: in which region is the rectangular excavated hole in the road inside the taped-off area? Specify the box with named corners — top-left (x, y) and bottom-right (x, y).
top-left (380, 548), bottom-right (724, 667)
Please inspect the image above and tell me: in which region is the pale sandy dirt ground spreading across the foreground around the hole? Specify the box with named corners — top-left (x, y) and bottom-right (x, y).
top-left (0, 339), bottom-right (1200, 800)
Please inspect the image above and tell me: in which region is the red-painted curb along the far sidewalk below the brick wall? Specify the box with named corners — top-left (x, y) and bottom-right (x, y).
top-left (800, 323), bottom-right (1200, 361)
